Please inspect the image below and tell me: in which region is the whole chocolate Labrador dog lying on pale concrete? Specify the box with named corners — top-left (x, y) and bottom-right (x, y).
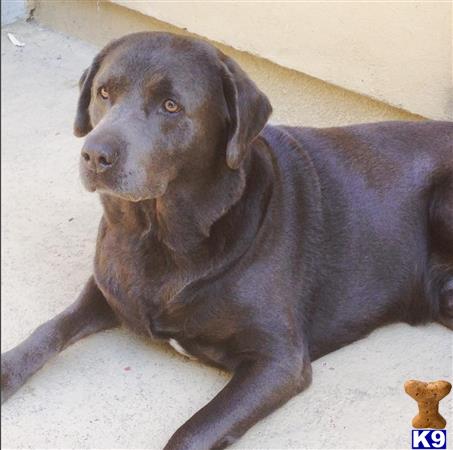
top-left (2, 29), bottom-right (453, 450)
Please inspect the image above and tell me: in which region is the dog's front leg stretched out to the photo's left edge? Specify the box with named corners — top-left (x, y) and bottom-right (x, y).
top-left (1, 277), bottom-right (118, 402)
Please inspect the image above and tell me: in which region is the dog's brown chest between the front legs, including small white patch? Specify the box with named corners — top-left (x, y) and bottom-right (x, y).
top-left (94, 225), bottom-right (242, 367)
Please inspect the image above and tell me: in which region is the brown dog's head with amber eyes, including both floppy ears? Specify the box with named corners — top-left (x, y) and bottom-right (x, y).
top-left (74, 33), bottom-right (271, 201)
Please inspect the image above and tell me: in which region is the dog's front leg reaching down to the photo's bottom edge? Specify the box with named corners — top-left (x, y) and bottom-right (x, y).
top-left (165, 356), bottom-right (311, 450)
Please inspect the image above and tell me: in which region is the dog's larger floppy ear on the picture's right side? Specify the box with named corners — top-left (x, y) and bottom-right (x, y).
top-left (220, 53), bottom-right (272, 169)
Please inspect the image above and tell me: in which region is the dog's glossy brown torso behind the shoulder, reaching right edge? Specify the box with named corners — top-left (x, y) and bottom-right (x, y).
top-left (267, 122), bottom-right (453, 357)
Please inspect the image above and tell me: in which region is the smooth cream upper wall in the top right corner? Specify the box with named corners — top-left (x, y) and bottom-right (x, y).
top-left (112, 0), bottom-right (453, 119)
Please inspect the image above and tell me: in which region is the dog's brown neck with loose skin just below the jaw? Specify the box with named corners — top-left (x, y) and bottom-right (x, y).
top-left (101, 142), bottom-right (269, 259)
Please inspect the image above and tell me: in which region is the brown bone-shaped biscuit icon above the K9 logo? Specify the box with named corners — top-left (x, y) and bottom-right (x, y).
top-left (404, 380), bottom-right (451, 429)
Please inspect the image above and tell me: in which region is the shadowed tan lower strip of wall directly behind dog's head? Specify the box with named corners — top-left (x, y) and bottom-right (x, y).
top-left (34, 0), bottom-right (420, 126)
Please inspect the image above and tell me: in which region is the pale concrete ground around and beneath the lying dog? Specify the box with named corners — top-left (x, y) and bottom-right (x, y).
top-left (1, 24), bottom-right (453, 449)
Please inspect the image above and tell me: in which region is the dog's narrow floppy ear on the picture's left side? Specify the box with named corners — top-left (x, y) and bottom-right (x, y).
top-left (74, 54), bottom-right (103, 137)
